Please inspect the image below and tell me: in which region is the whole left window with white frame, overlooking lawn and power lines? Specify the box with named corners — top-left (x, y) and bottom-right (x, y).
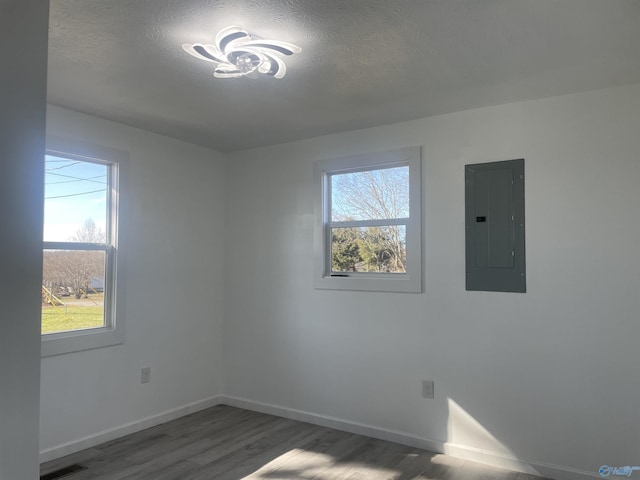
top-left (41, 139), bottom-right (123, 356)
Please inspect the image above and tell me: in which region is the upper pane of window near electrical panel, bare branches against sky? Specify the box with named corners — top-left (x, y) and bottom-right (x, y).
top-left (331, 166), bottom-right (409, 222)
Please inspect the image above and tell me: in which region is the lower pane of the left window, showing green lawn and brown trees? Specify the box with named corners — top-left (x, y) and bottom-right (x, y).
top-left (42, 250), bottom-right (106, 333)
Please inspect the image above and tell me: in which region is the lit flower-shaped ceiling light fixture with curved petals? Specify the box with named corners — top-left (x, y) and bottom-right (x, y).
top-left (182, 25), bottom-right (302, 78)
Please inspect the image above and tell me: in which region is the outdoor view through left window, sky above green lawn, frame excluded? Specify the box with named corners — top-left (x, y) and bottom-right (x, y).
top-left (42, 155), bottom-right (109, 333)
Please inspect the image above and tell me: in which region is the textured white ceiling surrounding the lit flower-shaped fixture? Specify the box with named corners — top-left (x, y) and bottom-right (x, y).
top-left (48, 0), bottom-right (640, 151)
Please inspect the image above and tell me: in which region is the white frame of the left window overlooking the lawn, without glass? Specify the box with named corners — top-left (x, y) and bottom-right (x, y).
top-left (41, 138), bottom-right (128, 357)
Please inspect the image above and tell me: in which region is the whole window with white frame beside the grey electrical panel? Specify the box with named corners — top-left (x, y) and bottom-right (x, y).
top-left (315, 147), bottom-right (422, 292)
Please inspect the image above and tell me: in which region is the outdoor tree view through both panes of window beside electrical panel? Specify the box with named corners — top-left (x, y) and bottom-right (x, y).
top-left (330, 166), bottom-right (409, 273)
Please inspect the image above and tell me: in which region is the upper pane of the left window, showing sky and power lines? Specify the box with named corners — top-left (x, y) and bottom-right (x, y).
top-left (44, 155), bottom-right (108, 243)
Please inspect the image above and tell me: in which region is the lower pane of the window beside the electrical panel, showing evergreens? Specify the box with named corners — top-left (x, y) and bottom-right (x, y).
top-left (331, 225), bottom-right (407, 273)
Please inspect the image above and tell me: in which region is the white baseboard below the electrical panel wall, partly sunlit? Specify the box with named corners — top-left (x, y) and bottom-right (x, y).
top-left (220, 395), bottom-right (600, 480)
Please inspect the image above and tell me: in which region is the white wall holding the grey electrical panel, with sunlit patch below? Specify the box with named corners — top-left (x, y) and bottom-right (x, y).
top-left (225, 85), bottom-right (640, 478)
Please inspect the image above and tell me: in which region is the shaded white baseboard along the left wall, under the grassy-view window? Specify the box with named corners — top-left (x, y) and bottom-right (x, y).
top-left (40, 395), bottom-right (225, 463)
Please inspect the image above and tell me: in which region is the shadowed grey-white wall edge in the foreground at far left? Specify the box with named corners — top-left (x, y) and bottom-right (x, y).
top-left (0, 0), bottom-right (49, 480)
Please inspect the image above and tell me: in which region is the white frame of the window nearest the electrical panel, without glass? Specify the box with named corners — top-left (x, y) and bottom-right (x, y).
top-left (314, 147), bottom-right (422, 293)
